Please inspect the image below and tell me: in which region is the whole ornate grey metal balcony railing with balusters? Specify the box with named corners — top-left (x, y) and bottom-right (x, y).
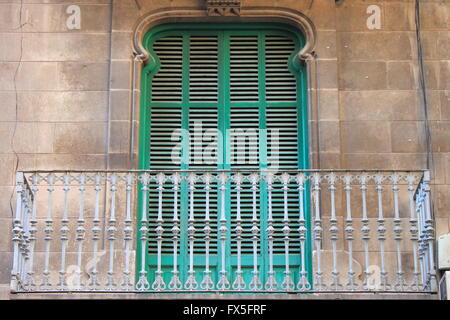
top-left (11, 170), bottom-right (436, 293)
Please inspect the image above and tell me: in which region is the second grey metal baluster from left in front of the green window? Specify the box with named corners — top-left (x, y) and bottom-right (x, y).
top-left (152, 173), bottom-right (166, 291)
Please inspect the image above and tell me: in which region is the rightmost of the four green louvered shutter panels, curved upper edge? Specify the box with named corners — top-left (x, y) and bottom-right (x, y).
top-left (265, 35), bottom-right (300, 255)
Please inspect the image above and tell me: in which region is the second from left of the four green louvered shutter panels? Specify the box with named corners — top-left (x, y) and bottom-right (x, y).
top-left (189, 35), bottom-right (218, 255)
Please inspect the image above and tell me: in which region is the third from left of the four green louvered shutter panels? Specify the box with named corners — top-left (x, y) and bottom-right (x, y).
top-left (229, 35), bottom-right (260, 255)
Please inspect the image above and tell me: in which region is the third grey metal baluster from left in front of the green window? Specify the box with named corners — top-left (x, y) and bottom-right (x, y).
top-left (169, 173), bottom-right (182, 290)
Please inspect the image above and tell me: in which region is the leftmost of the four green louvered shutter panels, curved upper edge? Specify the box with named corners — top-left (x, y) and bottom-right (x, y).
top-left (148, 36), bottom-right (183, 254)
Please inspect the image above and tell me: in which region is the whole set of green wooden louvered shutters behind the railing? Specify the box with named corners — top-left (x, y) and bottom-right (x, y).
top-left (141, 25), bottom-right (307, 283)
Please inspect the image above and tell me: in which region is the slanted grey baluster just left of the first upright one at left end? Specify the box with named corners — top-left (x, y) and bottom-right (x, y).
top-left (25, 173), bottom-right (41, 290)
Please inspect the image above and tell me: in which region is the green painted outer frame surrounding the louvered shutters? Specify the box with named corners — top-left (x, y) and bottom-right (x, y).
top-left (136, 23), bottom-right (312, 290)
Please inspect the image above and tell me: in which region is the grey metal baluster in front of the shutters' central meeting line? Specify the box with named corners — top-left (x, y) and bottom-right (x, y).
top-left (216, 172), bottom-right (230, 290)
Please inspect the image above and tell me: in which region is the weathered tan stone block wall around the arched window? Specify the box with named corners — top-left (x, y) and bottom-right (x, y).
top-left (0, 0), bottom-right (450, 298)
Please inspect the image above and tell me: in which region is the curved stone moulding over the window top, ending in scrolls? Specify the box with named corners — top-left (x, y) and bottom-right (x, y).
top-left (133, 7), bottom-right (316, 62)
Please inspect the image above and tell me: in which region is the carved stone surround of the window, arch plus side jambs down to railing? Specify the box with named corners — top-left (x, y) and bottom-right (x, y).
top-left (129, 7), bottom-right (320, 168)
